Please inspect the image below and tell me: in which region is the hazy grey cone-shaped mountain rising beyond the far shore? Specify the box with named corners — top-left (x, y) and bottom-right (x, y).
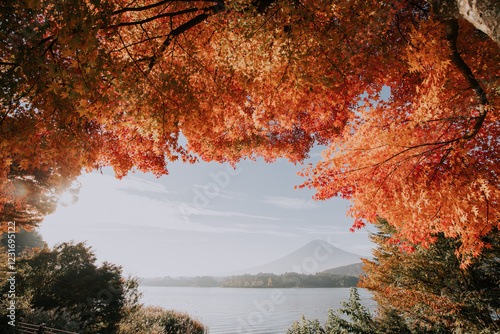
top-left (227, 240), bottom-right (361, 275)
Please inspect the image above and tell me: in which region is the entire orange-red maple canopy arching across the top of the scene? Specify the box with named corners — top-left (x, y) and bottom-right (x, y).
top-left (0, 0), bottom-right (500, 258)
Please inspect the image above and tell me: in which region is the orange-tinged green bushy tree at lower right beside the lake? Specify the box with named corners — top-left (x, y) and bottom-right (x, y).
top-left (359, 218), bottom-right (500, 333)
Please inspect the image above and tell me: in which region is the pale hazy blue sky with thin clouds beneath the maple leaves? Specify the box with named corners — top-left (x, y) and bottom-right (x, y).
top-left (40, 146), bottom-right (371, 277)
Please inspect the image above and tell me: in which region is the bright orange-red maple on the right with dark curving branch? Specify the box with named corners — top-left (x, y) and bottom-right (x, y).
top-left (296, 2), bottom-right (500, 260)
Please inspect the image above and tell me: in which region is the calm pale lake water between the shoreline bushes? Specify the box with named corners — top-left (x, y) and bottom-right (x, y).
top-left (140, 286), bottom-right (376, 334)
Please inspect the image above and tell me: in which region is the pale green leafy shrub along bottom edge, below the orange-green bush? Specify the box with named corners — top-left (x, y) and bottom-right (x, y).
top-left (286, 288), bottom-right (499, 334)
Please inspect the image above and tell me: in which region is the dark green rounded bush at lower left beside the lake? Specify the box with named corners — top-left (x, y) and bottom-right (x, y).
top-left (1, 243), bottom-right (129, 333)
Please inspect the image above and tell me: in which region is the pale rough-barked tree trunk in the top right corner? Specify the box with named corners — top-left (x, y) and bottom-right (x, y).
top-left (427, 0), bottom-right (500, 47)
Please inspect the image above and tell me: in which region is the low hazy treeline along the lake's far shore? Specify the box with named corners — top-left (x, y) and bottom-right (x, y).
top-left (140, 273), bottom-right (359, 288)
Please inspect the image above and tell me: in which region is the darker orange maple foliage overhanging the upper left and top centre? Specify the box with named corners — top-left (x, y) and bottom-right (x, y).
top-left (0, 1), bottom-right (361, 231)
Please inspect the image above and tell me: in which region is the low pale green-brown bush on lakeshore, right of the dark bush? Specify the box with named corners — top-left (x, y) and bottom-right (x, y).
top-left (117, 305), bottom-right (208, 334)
